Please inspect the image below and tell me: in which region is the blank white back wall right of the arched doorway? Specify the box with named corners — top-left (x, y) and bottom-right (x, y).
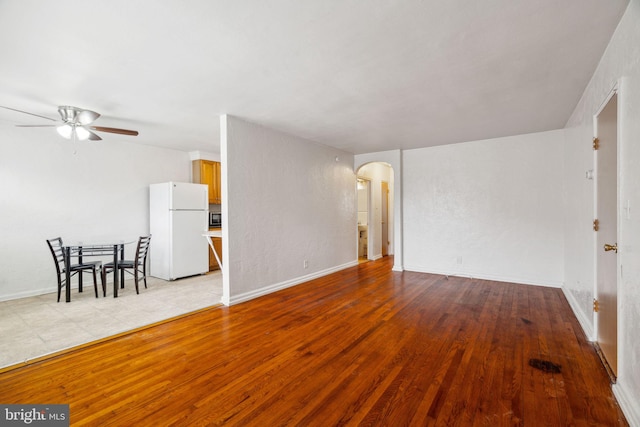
top-left (403, 131), bottom-right (564, 286)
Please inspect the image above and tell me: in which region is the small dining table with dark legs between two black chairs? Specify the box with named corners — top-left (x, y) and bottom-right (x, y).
top-left (62, 240), bottom-right (135, 302)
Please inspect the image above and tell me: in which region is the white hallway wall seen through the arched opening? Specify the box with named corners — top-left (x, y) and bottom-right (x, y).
top-left (358, 162), bottom-right (394, 260)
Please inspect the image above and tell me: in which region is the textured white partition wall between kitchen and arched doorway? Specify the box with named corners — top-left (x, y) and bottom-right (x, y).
top-left (220, 116), bottom-right (357, 304)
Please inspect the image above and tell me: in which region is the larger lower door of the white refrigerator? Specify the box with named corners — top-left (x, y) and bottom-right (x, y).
top-left (169, 211), bottom-right (209, 280)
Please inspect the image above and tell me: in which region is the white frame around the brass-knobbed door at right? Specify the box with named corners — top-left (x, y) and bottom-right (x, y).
top-left (593, 80), bottom-right (624, 377)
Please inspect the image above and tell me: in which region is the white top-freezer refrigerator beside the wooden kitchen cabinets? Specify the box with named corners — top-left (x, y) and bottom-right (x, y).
top-left (149, 182), bottom-right (209, 280)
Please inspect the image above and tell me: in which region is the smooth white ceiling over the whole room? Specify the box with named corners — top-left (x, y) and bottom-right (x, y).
top-left (0, 0), bottom-right (629, 154)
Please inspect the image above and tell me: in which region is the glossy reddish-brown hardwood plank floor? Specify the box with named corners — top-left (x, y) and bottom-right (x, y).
top-left (0, 258), bottom-right (627, 426)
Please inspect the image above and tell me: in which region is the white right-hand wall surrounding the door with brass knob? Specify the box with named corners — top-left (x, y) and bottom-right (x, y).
top-left (565, 0), bottom-right (640, 426)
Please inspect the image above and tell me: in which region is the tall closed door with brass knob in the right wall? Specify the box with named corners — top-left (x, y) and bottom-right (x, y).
top-left (595, 94), bottom-right (618, 375)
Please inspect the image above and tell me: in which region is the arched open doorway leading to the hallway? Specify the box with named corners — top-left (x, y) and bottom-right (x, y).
top-left (357, 162), bottom-right (394, 260)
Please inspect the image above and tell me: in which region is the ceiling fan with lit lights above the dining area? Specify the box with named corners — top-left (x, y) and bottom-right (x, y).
top-left (0, 105), bottom-right (138, 141)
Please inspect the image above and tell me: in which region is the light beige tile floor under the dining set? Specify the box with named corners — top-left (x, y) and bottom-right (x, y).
top-left (0, 271), bottom-right (222, 369)
